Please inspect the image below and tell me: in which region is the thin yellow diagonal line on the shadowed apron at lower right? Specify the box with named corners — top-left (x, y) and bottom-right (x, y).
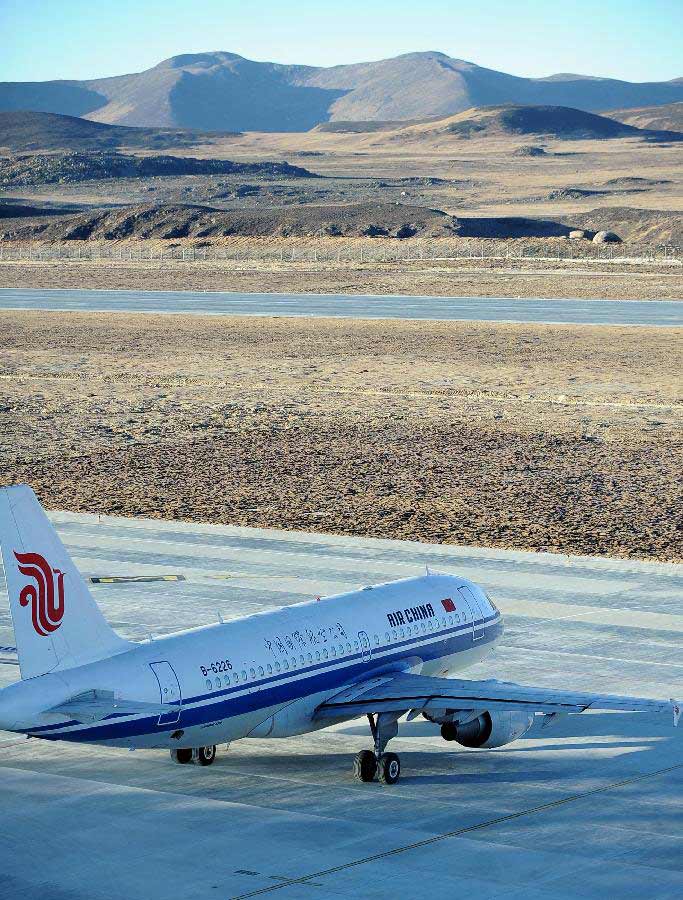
top-left (230, 763), bottom-right (683, 900)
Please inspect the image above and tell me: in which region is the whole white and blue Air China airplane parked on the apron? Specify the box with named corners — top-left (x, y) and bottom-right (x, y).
top-left (0, 485), bottom-right (681, 785)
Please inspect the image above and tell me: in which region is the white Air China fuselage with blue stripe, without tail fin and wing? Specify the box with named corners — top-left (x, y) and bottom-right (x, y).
top-left (0, 575), bottom-right (502, 748)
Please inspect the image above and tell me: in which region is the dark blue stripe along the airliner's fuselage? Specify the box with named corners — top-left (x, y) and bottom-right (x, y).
top-left (29, 616), bottom-right (503, 743)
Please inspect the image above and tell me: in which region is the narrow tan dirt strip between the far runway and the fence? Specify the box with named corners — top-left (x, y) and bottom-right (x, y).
top-left (0, 260), bottom-right (683, 300)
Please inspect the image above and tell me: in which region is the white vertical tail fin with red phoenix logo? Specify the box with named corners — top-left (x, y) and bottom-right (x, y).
top-left (0, 484), bottom-right (128, 678)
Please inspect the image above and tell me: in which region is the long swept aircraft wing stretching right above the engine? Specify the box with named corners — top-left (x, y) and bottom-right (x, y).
top-left (316, 673), bottom-right (681, 725)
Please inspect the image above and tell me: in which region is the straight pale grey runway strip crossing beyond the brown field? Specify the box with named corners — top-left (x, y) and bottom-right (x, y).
top-left (0, 288), bottom-right (683, 327)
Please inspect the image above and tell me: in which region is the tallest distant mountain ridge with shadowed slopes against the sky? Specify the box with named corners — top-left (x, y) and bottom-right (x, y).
top-left (0, 51), bottom-right (683, 131)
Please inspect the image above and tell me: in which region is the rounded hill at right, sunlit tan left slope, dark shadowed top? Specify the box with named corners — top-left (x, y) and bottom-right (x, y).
top-left (394, 105), bottom-right (681, 140)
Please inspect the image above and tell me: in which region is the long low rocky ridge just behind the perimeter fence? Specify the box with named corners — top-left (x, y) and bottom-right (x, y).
top-left (0, 203), bottom-right (683, 247)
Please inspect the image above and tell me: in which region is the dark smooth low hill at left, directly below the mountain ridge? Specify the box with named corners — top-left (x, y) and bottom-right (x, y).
top-left (0, 110), bottom-right (234, 152)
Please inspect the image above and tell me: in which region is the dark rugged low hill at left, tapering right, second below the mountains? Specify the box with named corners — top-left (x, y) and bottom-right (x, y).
top-left (0, 153), bottom-right (318, 187)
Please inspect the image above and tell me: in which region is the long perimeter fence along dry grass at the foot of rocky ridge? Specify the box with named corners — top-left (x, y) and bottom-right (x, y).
top-left (0, 239), bottom-right (683, 266)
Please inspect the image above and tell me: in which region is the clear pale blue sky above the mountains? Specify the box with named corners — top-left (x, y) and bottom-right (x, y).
top-left (0, 0), bottom-right (683, 81)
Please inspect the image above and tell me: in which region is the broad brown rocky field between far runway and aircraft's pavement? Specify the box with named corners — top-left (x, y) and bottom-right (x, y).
top-left (0, 312), bottom-right (683, 560)
